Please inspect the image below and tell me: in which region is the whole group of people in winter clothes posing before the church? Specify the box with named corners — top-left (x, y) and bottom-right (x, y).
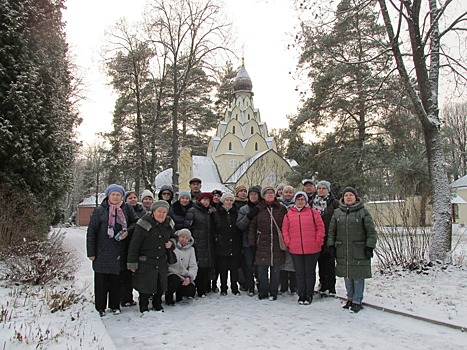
top-left (87, 178), bottom-right (377, 316)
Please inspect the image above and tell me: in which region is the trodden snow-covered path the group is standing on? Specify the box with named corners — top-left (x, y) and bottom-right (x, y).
top-left (67, 228), bottom-right (467, 349)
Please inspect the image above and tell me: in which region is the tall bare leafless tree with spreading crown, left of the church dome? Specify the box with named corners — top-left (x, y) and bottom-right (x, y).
top-left (147, 0), bottom-right (234, 190)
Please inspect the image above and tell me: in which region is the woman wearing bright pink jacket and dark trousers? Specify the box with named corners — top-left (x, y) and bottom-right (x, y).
top-left (282, 192), bottom-right (324, 305)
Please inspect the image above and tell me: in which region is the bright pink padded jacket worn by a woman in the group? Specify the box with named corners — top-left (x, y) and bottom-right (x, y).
top-left (282, 206), bottom-right (325, 254)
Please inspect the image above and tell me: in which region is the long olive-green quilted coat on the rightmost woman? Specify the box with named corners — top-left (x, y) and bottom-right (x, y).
top-left (327, 198), bottom-right (377, 279)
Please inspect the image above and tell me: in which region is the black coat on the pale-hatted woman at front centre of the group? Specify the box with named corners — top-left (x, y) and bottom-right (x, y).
top-left (214, 206), bottom-right (242, 256)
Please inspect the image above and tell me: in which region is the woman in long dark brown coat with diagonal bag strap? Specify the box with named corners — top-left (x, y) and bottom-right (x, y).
top-left (248, 186), bottom-right (287, 301)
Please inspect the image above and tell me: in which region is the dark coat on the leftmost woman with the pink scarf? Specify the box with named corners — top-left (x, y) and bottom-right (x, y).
top-left (86, 198), bottom-right (138, 275)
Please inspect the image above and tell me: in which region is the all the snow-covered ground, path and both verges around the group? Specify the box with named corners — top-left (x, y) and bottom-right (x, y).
top-left (0, 227), bottom-right (467, 349)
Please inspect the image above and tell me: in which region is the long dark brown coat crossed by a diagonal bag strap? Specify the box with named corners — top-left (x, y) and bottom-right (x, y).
top-left (248, 198), bottom-right (287, 266)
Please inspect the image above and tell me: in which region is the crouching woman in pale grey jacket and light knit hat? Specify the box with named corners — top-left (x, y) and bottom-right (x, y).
top-left (165, 228), bottom-right (198, 305)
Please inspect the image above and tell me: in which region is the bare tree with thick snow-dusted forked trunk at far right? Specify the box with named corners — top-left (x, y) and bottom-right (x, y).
top-left (376, 0), bottom-right (467, 260)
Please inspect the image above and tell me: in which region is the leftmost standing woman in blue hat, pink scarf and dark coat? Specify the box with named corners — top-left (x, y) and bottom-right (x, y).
top-left (86, 184), bottom-right (138, 317)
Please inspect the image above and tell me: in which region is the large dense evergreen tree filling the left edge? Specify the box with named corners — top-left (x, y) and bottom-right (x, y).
top-left (0, 0), bottom-right (78, 235)
